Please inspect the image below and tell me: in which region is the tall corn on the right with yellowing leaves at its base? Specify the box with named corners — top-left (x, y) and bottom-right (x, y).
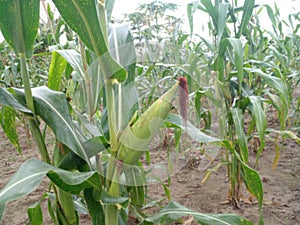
top-left (188, 0), bottom-right (299, 224)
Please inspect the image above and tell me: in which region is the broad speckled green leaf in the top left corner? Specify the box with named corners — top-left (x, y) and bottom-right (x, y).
top-left (0, 0), bottom-right (40, 58)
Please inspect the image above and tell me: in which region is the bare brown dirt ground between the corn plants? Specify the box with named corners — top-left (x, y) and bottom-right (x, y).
top-left (0, 115), bottom-right (300, 225)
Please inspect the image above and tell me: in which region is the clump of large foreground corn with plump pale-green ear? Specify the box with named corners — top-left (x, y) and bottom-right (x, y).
top-left (0, 0), bottom-right (253, 225)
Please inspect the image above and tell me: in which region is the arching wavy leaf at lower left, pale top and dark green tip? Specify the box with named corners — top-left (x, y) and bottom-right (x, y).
top-left (0, 159), bottom-right (101, 223)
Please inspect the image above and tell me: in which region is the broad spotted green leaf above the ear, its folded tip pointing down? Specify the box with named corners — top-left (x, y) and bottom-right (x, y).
top-left (53, 0), bottom-right (127, 82)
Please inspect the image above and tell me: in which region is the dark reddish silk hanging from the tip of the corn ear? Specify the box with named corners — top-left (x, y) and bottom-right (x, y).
top-left (178, 77), bottom-right (189, 126)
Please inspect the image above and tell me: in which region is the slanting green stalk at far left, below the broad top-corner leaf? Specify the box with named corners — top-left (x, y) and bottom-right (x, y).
top-left (19, 53), bottom-right (51, 164)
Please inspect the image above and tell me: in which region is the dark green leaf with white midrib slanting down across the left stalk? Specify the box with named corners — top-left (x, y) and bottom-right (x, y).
top-left (16, 87), bottom-right (91, 168)
